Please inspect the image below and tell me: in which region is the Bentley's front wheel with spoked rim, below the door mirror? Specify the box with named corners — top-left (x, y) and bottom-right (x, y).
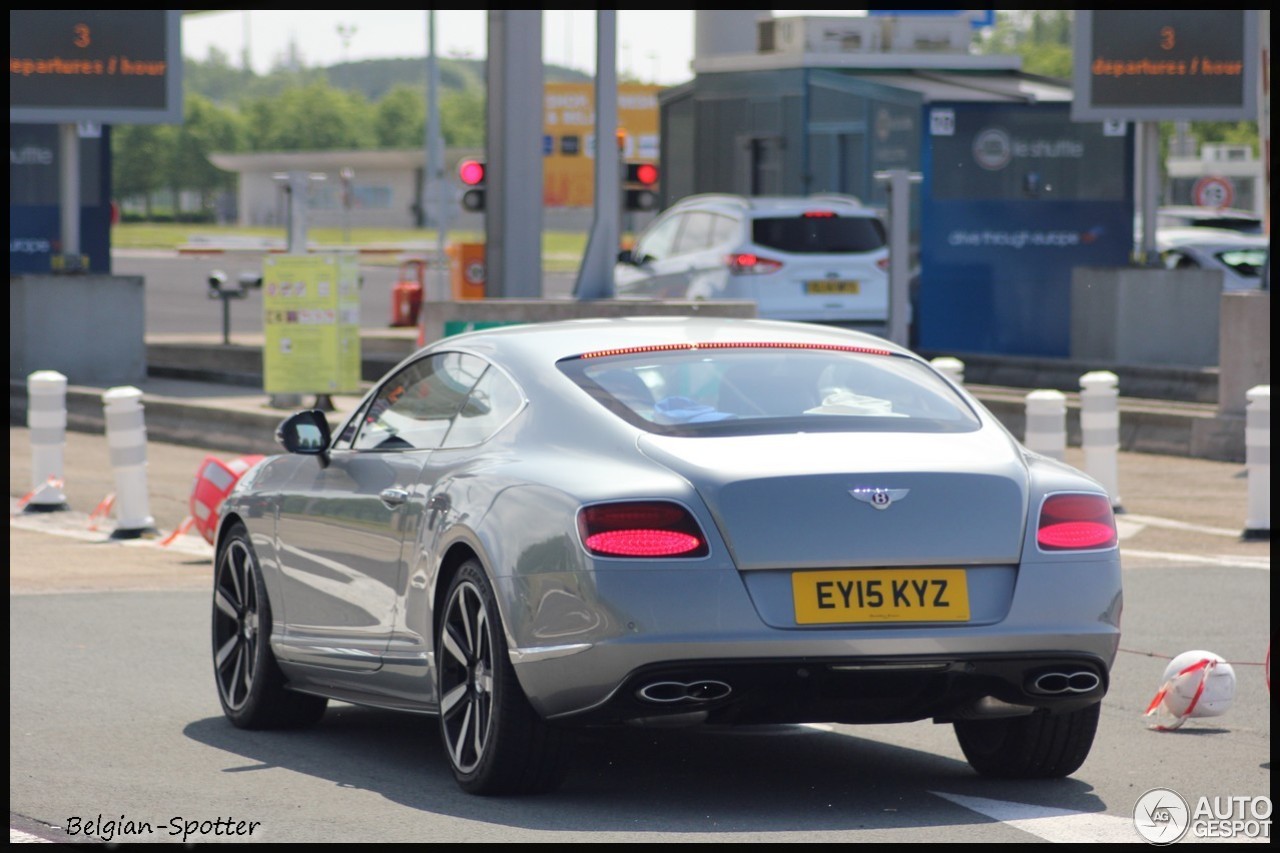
top-left (212, 524), bottom-right (329, 729)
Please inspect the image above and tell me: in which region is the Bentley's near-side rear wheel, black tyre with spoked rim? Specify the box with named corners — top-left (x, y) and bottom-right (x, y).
top-left (435, 560), bottom-right (566, 795)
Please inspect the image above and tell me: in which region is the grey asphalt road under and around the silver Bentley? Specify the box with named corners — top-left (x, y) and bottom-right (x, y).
top-left (9, 427), bottom-right (1271, 843)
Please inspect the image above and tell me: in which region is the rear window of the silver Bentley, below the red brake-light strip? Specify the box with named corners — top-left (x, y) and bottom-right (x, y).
top-left (559, 342), bottom-right (979, 435)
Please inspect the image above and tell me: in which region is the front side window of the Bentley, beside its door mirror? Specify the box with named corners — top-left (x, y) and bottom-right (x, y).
top-left (352, 352), bottom-right (485, 451)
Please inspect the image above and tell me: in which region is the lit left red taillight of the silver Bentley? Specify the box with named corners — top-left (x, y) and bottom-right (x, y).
top-left (577, 501), bottom-right (708, 557)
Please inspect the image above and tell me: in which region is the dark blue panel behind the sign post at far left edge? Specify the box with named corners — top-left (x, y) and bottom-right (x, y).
top-left (9, 124), bottom-right (111, 275)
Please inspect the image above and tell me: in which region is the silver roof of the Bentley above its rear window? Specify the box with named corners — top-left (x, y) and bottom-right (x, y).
top-left (428, 316), bottom-right (910, 366)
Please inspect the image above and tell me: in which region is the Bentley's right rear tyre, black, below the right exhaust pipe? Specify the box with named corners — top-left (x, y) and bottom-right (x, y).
top-left (955, 702), bottom-right (1102, 779)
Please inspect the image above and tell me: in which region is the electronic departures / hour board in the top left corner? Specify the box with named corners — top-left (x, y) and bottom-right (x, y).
top-left (9, 9), bottom-right (182, 124)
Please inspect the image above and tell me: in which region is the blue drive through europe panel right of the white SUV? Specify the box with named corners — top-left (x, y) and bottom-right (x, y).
top-left (915, 102), bottom-right (1134, 357)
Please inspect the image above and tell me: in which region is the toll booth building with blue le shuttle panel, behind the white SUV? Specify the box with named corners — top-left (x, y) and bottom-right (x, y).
top-left (659, 10), bottom-right (1134, 357)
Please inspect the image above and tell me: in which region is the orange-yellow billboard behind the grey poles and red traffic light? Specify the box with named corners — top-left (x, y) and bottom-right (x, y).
top-left (543, 83), bottom-right (662, 207)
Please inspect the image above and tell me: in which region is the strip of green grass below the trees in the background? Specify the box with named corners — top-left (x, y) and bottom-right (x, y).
top-left (111, 223), bottom-right (586, 272)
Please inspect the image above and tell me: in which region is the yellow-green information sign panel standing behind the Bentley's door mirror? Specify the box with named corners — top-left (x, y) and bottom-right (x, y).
top-left (262, 254), bottom-right (360, 394)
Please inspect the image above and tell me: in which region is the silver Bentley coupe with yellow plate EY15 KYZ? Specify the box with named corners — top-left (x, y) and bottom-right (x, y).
top-left (212, 318), bottom-right (1121, 794)
